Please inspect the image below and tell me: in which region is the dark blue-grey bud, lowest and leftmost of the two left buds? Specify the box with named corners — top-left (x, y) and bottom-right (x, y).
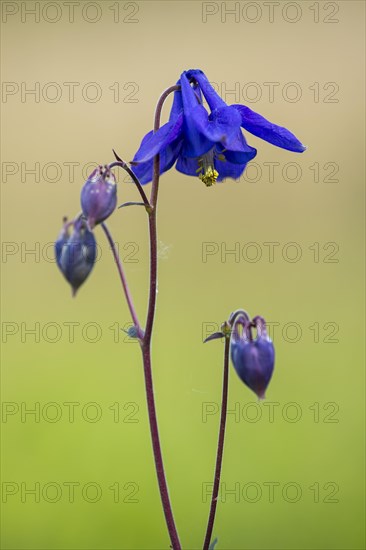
top-left (55, 216), bottom-right (97, 296)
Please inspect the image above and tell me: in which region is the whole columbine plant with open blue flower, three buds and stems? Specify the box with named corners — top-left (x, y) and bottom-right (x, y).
top-left (55, 70), bottom-right (305, 550)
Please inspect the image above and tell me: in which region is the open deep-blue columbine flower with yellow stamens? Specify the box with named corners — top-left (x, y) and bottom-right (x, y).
top-left (132, 70), bottom-right (305, 186)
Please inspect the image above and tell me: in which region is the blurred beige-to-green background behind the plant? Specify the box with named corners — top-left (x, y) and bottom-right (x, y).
top-left (1, 1), bottom-right (365, 550)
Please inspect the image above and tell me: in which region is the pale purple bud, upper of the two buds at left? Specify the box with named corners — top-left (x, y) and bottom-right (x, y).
top-left (81, 166), bottom-right (117, 229)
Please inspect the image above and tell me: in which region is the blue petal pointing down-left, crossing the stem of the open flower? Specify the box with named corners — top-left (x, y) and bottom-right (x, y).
top-left (133, 112), bottom-right (183, 162)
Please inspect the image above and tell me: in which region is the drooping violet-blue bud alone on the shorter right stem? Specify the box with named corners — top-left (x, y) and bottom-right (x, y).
top-left (231, 316), bottom-right (275, 399)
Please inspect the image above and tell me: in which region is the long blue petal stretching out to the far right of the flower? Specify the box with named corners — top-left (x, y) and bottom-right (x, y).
top-left (233, 105), bottom-right (306, 153)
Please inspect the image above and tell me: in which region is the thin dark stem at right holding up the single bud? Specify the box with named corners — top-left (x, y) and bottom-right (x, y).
top-left (203, 335), bottom-right (230, 550)
